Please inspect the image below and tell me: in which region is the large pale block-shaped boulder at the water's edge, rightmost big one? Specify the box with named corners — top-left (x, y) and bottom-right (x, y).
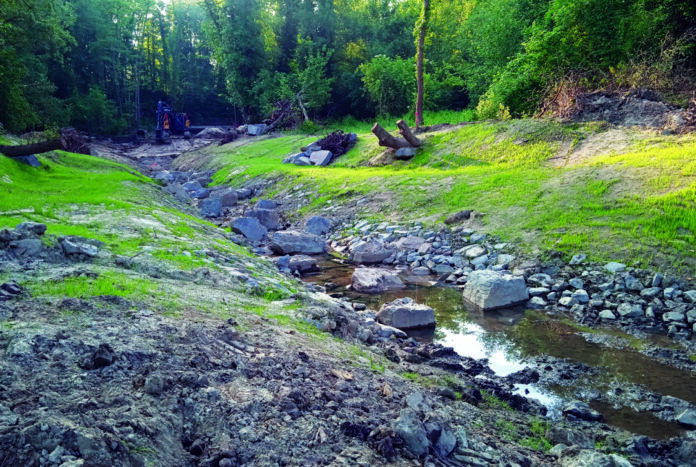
top-left (464, 270), bottom-right (529, 311)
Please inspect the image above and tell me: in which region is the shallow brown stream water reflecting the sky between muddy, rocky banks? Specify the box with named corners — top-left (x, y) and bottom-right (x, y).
top-left (304, 259), bottom-right (696, 440)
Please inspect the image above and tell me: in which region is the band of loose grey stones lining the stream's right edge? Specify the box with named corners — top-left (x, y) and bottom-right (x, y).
top-left (330, 221), bottom-right (696, 338)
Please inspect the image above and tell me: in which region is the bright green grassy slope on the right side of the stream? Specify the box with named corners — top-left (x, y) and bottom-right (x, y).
top-left (198, 120), bottom-right (696, 272)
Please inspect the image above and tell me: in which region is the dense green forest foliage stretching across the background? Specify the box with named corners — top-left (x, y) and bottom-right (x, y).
top-left (0, 0), bottom-right (696, 134)
